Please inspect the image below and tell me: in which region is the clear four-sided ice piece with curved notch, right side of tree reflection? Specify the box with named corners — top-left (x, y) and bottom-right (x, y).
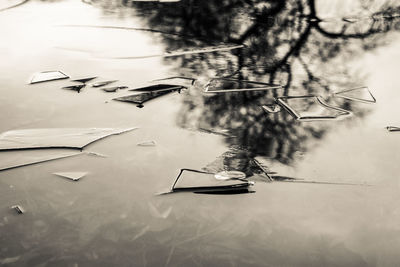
top-left (276, 95), bottom-right (351, 121)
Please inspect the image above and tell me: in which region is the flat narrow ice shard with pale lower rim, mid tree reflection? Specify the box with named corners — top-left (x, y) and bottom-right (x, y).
top-left (204, 78), bottom-right (282, 93)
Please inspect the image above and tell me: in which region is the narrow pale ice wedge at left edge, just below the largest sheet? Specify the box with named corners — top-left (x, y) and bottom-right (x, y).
top-left (0, 149), bottom-right (81, 171)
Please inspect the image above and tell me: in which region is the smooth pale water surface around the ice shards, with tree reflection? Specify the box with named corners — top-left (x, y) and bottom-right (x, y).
top-left (0, 0), bottom-right (400, 266)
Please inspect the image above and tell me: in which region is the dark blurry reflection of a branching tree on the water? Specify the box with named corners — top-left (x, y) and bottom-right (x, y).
top-left (95, 0), bottom-right (400, 174)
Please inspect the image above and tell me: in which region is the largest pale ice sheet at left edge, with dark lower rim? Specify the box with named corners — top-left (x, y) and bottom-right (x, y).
top-left (0, 128), bottom-right (136, 150)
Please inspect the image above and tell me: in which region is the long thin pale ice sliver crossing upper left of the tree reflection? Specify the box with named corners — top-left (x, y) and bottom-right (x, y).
top-left (114, 44), bottom-right (244, 59)
